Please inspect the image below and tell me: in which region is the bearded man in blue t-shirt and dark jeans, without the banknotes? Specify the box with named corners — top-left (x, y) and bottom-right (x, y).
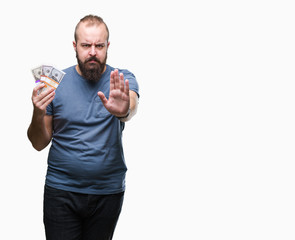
top-left (28, 15), bottom-right (139, 240)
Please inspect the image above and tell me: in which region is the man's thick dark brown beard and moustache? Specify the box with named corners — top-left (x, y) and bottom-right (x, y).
top-left (76, 52), bottom-right (107, 82)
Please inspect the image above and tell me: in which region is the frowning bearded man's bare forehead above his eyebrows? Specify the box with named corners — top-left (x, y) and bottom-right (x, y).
top-left (77, 22), bottom-right (108, 42)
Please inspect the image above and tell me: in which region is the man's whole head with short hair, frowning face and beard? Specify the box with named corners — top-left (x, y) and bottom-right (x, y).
top-left (73, 15), bottom-right (110, 82)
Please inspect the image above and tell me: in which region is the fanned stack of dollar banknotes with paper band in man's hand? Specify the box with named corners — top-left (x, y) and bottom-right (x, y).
top-left (32, 65), bottom-right (65, 93)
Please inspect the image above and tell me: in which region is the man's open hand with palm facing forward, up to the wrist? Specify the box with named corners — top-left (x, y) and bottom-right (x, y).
top-left (97, 69), bottom-right (130, 117)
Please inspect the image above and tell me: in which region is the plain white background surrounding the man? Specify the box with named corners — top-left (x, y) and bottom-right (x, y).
top-left (0, 0), bottom-right (295, 240)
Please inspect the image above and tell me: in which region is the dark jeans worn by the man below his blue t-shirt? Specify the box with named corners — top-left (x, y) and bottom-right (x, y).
top-left (44, 186), bottom-right (124, 240)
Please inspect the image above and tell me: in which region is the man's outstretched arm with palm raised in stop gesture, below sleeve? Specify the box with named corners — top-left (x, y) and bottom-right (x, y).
top-left (97, 69), bottom-right (138, 122)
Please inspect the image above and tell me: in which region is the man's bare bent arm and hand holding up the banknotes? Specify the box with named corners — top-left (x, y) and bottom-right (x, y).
top-left (27, 84), bottom-right (55, 151)
